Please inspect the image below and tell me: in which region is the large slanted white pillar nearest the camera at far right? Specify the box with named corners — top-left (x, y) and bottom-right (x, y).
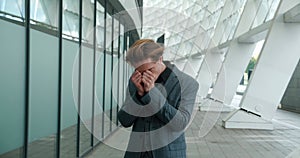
top-left (223, 0), bottom-right (300, 129)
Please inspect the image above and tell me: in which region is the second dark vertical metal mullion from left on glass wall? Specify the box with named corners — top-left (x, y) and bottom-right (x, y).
top-left (56, 0), bottom-right (63, 158)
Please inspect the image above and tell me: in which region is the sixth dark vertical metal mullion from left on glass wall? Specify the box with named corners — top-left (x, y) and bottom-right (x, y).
top-left (109, 9), bottom-right (115, 132)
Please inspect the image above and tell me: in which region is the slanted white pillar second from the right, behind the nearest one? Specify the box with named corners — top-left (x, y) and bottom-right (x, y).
top-left (202, 40), bottom-right (256, 111)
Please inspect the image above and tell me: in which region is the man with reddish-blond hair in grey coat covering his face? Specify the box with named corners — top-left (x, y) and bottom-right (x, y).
top-left (118, 39), bottom-right (198, 158)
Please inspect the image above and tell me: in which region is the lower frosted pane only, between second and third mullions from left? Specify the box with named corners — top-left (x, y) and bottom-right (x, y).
top-left (60, 38), bottom-right (79, 157)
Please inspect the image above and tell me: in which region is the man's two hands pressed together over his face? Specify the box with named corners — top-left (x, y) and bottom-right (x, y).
top-left (130, 70), bottom-right (157, 96)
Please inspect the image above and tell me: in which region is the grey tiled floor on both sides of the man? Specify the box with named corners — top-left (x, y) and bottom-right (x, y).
top-left (86, 110), bottom-right (300, 158)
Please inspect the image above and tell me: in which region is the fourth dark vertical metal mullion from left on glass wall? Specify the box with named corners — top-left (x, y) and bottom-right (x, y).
top-left (91, 0), bottom-right (97, 147)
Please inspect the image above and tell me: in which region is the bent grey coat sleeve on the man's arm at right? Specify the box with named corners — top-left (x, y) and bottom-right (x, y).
top-left (144, 78), bottom-right (199, 131)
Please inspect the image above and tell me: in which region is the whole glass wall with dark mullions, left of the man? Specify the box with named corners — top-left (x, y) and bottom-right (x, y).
top-left (0, 0), bottom-right (132, 158)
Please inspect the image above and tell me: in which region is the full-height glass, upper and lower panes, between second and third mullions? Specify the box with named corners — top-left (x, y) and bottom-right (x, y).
top-left (60, 0), bottom-right (79, 158)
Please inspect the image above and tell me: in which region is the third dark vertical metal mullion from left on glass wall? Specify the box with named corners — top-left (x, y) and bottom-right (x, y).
top-left (76, 0), bottom-right (82, 157)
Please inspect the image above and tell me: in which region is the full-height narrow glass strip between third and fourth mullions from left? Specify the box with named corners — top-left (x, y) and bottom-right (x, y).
top-left (80, 0), bottom-right (94, 155)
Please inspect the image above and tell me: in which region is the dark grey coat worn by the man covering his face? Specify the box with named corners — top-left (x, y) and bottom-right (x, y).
top-left (118, 62), bottom-right (199, 158)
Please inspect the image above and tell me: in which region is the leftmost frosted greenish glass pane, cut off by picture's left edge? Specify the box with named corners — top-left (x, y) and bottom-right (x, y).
top-left (0, 0), bottom-right (26, 158)
